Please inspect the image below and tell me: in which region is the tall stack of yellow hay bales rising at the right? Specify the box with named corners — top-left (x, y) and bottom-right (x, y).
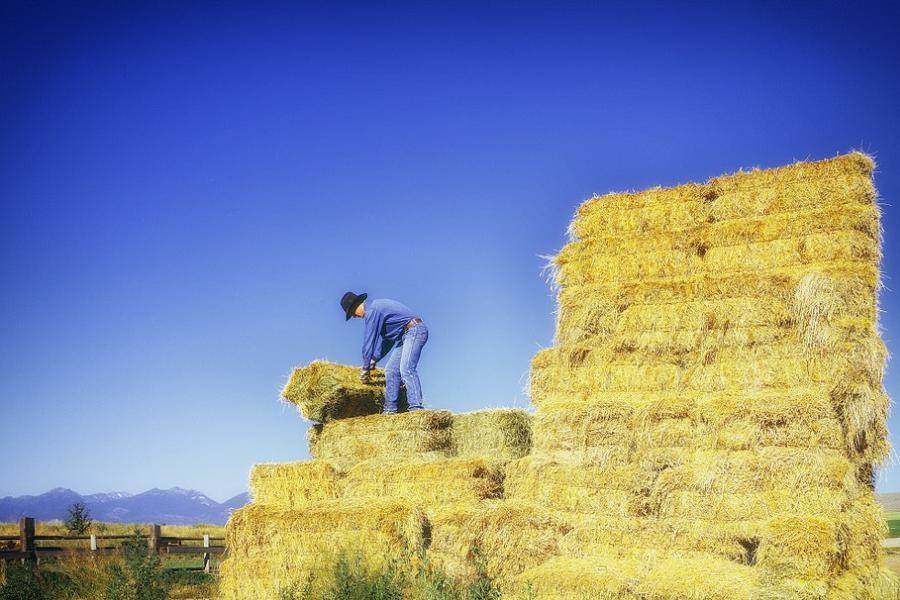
top-left (505, 153), bottom-right (888, 600)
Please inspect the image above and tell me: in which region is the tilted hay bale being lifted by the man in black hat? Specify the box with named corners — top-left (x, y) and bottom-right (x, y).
top-left (281, 360), bottom-right (402, 423)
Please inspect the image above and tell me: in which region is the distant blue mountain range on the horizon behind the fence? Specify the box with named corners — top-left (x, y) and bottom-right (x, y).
top-left (0, 487), bottom-right (250, 525)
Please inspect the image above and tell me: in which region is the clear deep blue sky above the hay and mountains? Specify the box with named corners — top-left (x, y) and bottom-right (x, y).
top-left (0, 0), bottom-right (900, 500)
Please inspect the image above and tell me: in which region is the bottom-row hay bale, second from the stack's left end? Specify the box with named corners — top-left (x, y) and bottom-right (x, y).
top-left (428, 500), bottom-right (571, 589)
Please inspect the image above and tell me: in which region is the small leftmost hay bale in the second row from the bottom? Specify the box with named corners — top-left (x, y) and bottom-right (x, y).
top-left (250, 460), bottom-right (341, 508)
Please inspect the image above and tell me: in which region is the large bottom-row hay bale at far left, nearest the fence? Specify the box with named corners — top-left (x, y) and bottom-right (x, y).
top-left (220, 499), bottom-right (427, 600)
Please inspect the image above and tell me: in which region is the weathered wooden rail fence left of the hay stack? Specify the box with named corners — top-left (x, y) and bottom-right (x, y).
top-left (0, 517), bottom-right (225, 573)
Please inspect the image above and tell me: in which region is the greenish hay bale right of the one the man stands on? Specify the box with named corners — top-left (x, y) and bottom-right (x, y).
top-left (453, 408), bottom-right (532, 460)
